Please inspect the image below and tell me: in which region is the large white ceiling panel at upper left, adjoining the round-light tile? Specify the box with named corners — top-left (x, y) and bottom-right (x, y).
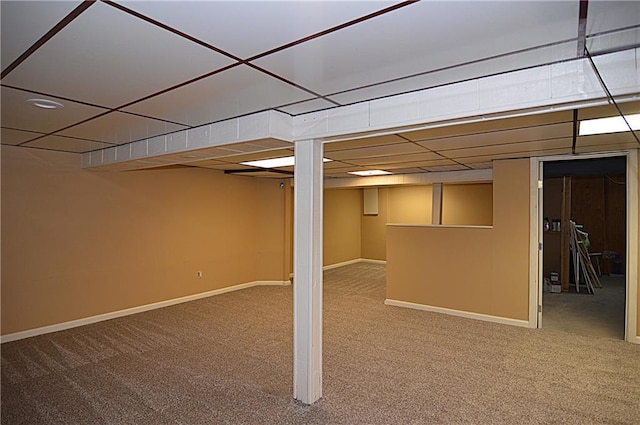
top-left (3, 2), bottom-right (232, 107)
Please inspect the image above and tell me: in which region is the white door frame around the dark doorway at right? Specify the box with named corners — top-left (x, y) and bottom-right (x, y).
top-left (529, 150), bottom-right (640, 344)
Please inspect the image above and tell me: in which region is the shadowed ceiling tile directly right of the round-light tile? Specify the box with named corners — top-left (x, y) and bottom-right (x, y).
top-left (60, 112), bottom-right (186, 144)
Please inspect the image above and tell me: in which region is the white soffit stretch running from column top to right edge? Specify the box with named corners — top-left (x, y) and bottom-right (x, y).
top-left (293, 49), bottom-right (640, 141)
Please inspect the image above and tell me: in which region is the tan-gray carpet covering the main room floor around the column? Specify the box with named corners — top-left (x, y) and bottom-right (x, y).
top-left (1, 264), bottom-right (640, 425)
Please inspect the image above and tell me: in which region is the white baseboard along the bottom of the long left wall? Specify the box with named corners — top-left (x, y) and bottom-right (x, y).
top-left (0, 280), bottom-right (291, 344)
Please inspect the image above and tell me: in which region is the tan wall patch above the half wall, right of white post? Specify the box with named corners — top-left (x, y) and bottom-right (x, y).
top-left (442, 183), bottom-right (493, 226)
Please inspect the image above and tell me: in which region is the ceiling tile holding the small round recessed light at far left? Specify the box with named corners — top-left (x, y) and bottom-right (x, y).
top-left (0, 87), bottom-right (105, 133)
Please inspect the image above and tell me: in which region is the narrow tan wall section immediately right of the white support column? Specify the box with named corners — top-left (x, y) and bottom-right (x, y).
top-left (322, 189), bottom-right (362, 266)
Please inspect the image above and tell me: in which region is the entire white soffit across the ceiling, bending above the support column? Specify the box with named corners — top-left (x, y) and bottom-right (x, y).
top-left (83, 49), bottom-right (640, 166)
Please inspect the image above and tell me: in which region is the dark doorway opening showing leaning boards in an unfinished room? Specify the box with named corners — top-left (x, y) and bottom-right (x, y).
top-left (541, 156), bottom-right (628, 339)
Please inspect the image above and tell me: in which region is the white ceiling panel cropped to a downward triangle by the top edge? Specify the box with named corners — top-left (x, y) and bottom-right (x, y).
top-left (119, 1), bottom-right (393, 59)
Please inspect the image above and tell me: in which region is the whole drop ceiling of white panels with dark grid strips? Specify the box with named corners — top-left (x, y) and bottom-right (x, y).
top-left (0, 0), bottom-right (640, 177)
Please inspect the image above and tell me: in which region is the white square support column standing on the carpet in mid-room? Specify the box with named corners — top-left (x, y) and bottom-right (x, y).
top-left (293, 140), bottom-right (323, 404)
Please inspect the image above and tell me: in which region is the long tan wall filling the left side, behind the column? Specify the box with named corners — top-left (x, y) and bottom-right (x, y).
top-left (2, 146), bottom-right (288, 334)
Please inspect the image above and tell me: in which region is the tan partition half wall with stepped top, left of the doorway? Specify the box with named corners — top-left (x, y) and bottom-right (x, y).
top-left (387, 160), bottom-right (529, 320)
